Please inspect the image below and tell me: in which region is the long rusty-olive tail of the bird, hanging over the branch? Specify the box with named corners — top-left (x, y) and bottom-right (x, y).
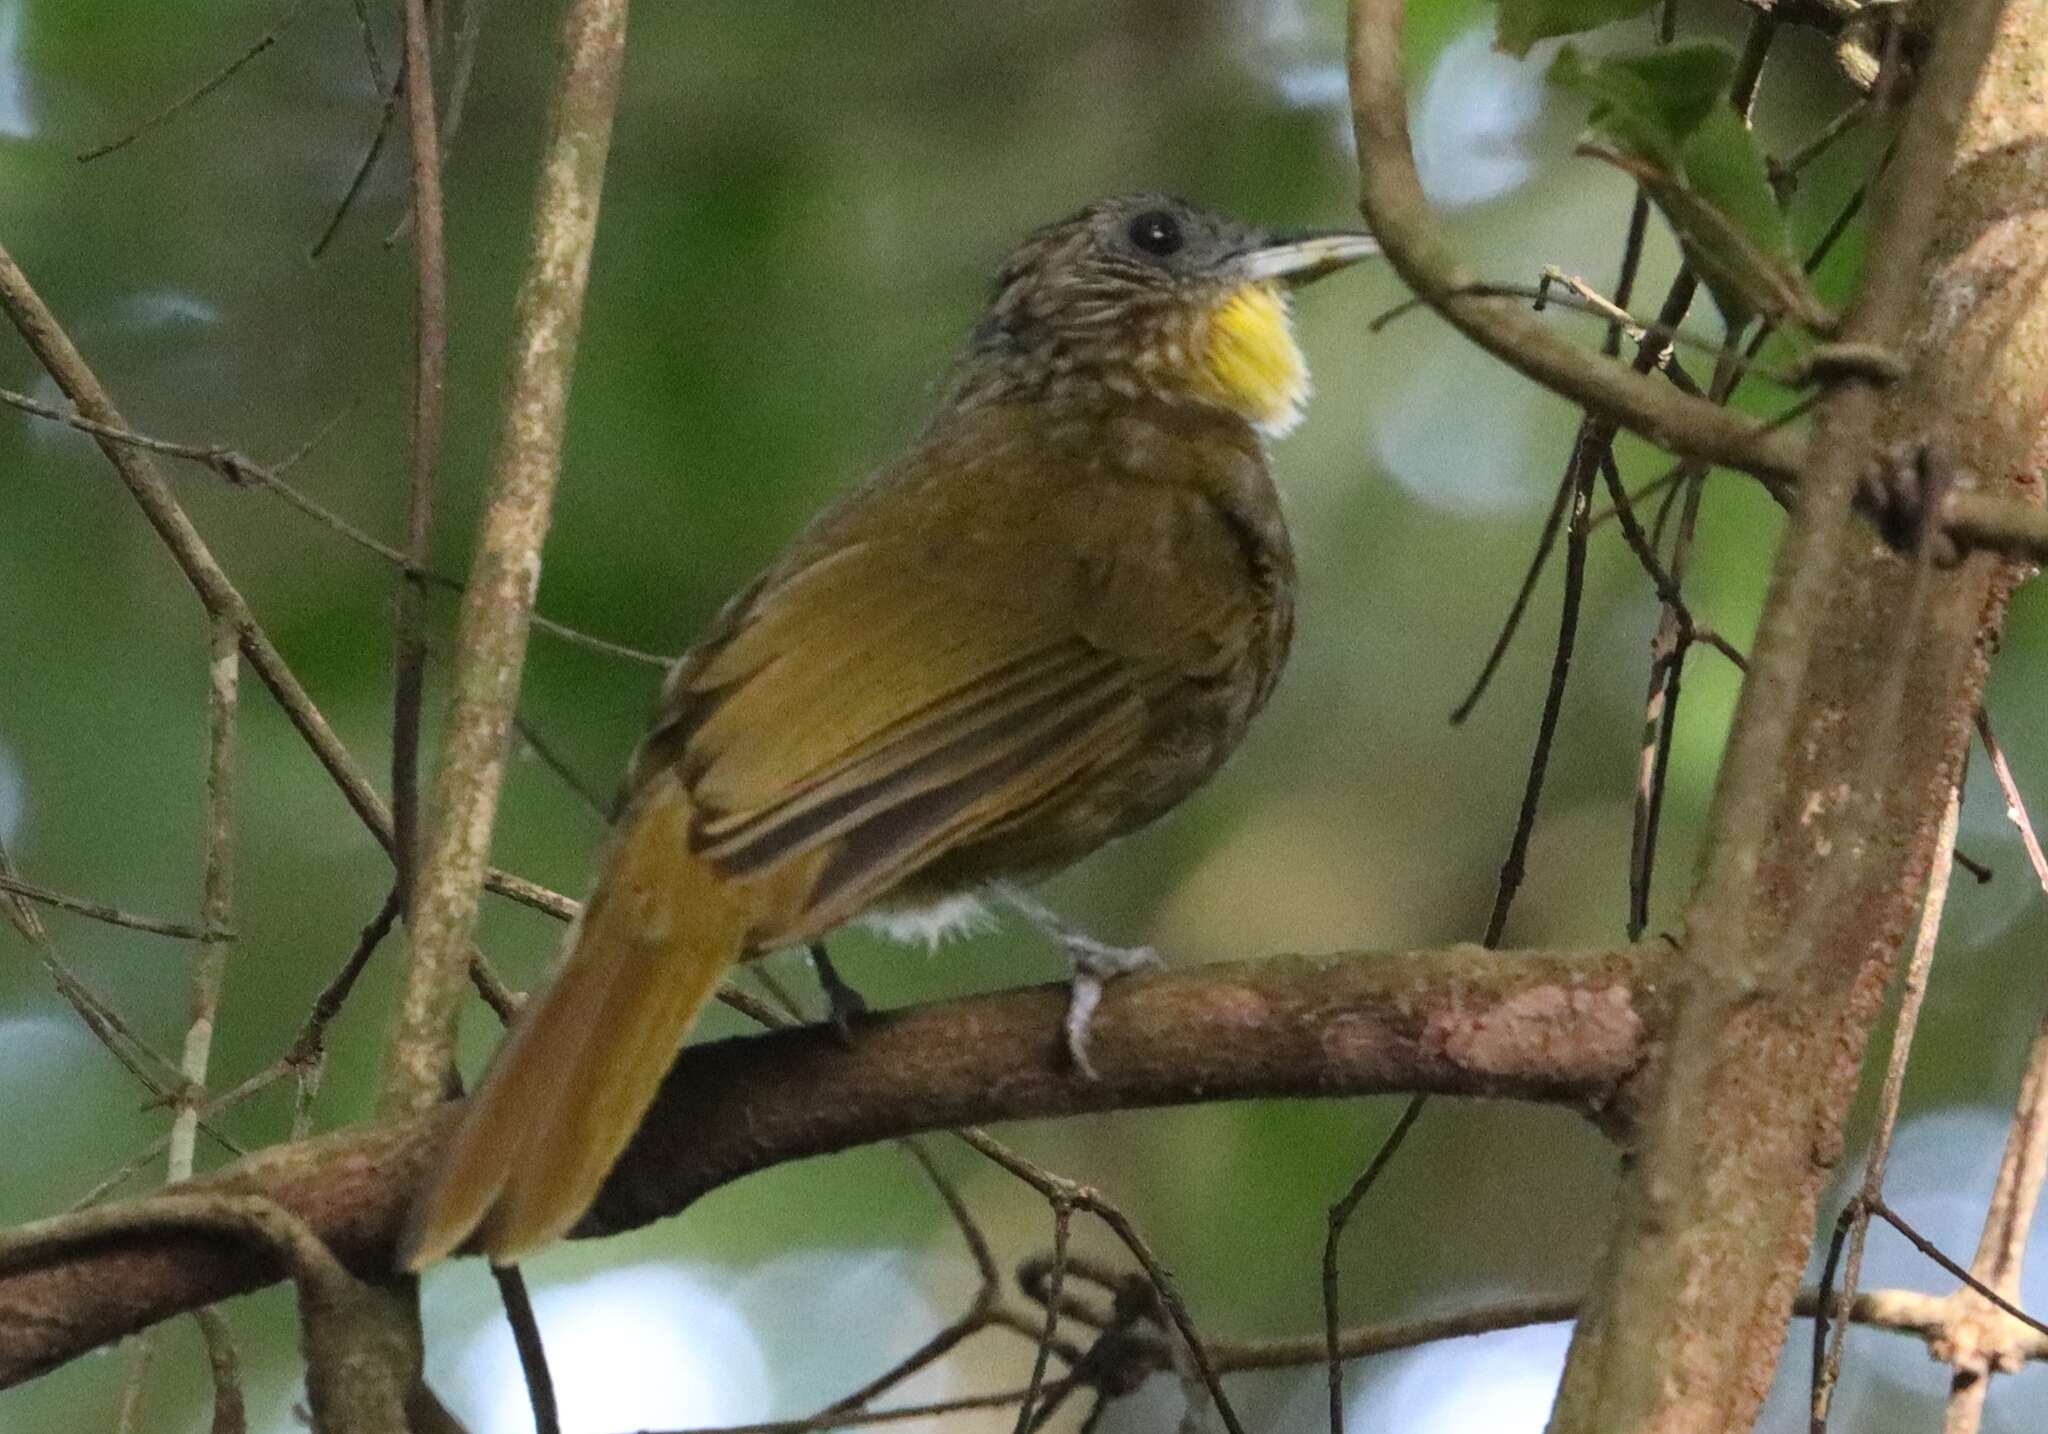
top-left (399, 778), bottom-right (748, 1270)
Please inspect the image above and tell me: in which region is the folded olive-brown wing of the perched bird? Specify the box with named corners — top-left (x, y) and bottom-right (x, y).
top-left (637, 409), bottom-right (1245, 940)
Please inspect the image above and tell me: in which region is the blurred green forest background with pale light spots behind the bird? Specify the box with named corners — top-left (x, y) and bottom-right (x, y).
top-left (0, 0), bottom-right (2048, 1434)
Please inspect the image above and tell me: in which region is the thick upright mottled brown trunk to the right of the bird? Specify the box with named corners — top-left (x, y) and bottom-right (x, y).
top-left (1550, 0), bottom-right (2048, 1434)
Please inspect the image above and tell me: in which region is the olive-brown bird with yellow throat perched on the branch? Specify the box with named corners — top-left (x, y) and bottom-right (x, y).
top-left (399, 193), bottom-right (1376, 1272)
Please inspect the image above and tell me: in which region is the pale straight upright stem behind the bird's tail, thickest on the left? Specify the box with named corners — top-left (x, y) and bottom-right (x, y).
top-left (385, 0), bottom-right (627, 1112)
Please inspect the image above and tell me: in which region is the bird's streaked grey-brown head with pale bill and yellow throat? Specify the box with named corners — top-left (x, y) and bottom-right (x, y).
top-left (954, 195), bottom-right (1378, 436)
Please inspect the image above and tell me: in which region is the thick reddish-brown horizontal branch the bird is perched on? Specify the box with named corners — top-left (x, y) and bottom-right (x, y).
top-left (0, 942), bottom-right (1671, 1387)
